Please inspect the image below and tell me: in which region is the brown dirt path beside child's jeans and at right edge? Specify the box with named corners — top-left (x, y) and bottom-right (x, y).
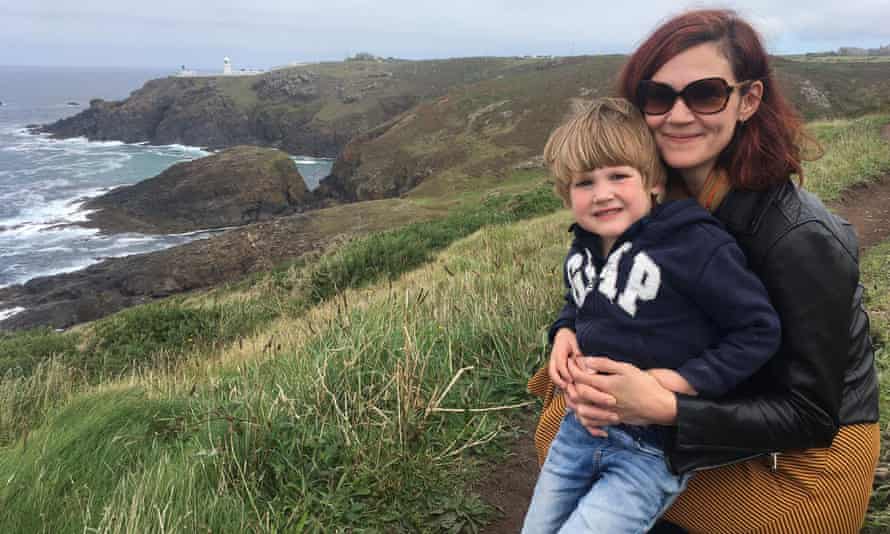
top-left (476, 125), bottom-right (890, 534)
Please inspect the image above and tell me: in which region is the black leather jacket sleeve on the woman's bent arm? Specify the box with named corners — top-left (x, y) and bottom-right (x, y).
top-left (673, 221), bottom-right (859, 453)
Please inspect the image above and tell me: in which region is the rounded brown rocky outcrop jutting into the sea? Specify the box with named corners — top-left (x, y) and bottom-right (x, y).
top-left (86, 146), bottom-right (310, 234)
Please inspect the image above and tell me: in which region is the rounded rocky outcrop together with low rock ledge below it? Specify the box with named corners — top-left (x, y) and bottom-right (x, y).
top-left (0, 146), bottom-right (344, 331)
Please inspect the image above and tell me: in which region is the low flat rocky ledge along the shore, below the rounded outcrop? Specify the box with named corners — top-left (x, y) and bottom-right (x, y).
top-left (0, 214), bottom-right (324, 332)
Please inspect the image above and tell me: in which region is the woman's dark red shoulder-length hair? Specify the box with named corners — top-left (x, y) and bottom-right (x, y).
top-left (618, 10), bottom-right (804, 190)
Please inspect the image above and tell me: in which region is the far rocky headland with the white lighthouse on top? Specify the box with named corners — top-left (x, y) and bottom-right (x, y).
top-left (40, 58), bottom-right (556, 157)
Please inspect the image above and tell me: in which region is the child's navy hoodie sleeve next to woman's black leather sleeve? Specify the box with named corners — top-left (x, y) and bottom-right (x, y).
top-left (677, 239), bottom-right (781, 398)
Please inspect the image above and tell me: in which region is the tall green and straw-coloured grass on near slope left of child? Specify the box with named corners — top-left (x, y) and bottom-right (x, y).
top-left (0, 214), bottom-right (567, 532)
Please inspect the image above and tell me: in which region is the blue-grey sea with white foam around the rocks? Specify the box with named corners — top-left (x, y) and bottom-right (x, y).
top-left (0, 66), bottom-right (332, 306)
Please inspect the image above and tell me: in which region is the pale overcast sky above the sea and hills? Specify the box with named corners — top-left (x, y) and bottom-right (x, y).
top-left (0, 0), bottom-right (890, 69)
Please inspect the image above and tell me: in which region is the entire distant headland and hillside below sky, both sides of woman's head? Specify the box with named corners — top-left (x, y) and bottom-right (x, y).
top-left (44, 55), bottom-right (890, 201)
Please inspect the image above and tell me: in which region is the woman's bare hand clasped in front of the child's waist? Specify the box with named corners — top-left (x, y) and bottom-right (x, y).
top-left (566, 357), bottom-right (677, 433)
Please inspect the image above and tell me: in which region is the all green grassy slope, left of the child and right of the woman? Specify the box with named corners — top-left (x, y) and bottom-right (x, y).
top-left (0, 116), bottom-right (890, 532)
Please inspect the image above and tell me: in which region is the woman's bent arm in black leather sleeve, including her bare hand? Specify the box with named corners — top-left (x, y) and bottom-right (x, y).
top-left (567, 221), bottom-right (858, 452)
